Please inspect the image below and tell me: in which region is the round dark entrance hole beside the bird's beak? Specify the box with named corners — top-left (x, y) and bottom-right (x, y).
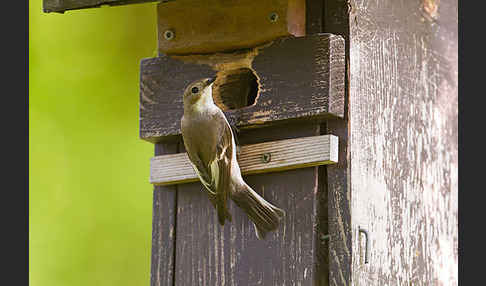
top-left (213, 67), bottom-right (259, 110)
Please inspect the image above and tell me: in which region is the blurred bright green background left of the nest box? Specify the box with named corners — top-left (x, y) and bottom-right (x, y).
top-left (29, 0), bottom-right (156, 286)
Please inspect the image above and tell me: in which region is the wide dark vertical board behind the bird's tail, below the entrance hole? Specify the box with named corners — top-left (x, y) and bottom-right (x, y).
top-left (175, 124), bottom-right (325, 286)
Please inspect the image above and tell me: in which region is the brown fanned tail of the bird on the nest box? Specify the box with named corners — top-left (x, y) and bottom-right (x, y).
top-left (231, 183), bottom-right (285, 239)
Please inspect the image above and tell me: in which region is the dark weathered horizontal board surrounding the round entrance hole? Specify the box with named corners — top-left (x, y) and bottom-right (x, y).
top-left (140, 34), bottom-right (345, 142)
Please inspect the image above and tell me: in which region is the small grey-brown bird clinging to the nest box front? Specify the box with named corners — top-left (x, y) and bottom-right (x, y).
top-left (181, 78), bottom-right (285, 239)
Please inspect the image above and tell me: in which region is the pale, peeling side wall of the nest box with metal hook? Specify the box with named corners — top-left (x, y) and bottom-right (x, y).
top-left (348, 0), bottom-right (458, 286)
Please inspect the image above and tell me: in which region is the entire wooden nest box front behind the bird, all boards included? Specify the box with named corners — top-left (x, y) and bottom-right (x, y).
top-left (140, 0), bottom-right (345, 285)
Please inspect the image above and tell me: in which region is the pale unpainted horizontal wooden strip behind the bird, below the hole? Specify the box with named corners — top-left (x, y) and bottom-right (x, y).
top-left (150, 135), bottom-right (338, 185)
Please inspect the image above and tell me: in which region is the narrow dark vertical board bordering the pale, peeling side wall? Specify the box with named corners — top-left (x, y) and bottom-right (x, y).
top-left (317, 0), bottom-right (352, 286)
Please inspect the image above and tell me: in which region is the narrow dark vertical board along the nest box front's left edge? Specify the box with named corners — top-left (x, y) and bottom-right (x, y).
top-left (150, 143), bottom-right (178, 286)
